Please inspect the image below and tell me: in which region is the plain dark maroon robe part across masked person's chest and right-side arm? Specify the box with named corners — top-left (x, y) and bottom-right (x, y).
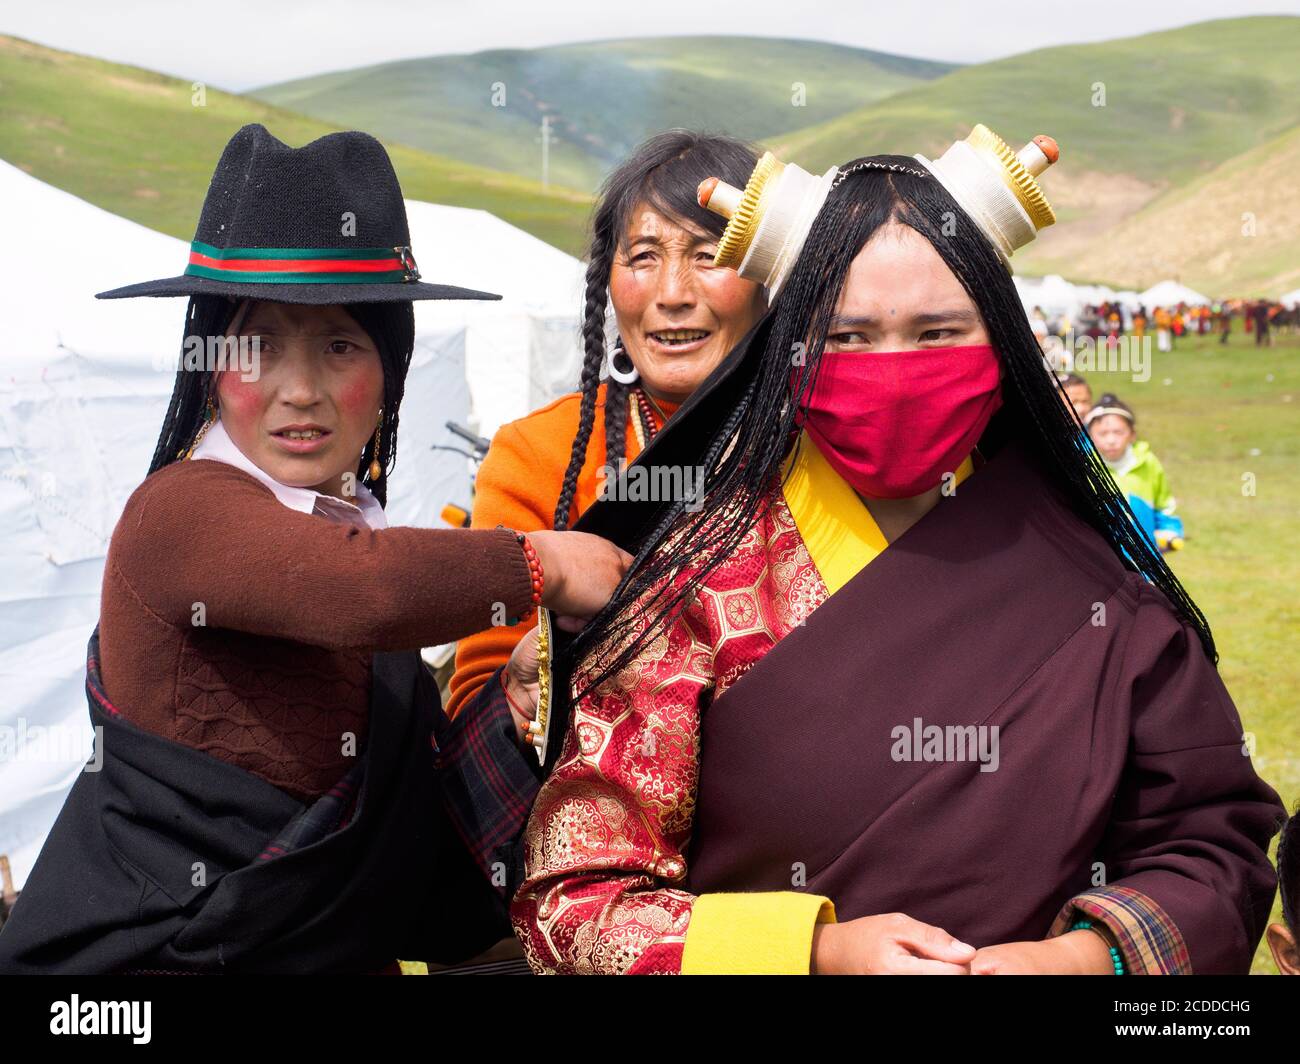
top-left (683, 437), bottom-right (1284, 973)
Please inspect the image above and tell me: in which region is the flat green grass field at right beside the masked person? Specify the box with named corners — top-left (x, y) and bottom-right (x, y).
top-left (1086, 323), bottom-right (1300, 974)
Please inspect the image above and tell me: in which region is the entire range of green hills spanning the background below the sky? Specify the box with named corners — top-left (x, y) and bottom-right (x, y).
top-left (0, 16), bottom-right (1300, 290)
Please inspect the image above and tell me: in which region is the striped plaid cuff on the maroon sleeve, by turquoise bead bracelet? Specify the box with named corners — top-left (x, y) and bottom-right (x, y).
top-left (1048, 887), bottom-right (1192, 976)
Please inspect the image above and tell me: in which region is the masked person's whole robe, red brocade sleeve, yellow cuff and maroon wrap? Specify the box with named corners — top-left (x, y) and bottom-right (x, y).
top-left (512, 431), bottom-right (1284, 974)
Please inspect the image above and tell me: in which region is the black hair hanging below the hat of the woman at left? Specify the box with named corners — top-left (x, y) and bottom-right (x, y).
top-left (150, 295), bottom-right (415, 506)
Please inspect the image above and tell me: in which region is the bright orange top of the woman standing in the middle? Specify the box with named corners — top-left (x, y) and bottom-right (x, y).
top-left (446, 384), bottom-right (679, 717)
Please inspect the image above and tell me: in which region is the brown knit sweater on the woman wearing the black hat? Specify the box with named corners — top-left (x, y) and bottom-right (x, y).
top-left (100, 462), bottom-right (532, 801)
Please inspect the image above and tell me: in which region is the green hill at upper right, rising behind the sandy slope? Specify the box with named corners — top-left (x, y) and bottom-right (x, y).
top-left (770, 17), bottom-right (1300, 185)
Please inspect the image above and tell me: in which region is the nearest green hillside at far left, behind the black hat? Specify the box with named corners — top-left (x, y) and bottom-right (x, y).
top-left (0, 35), bottom-right (590, 254)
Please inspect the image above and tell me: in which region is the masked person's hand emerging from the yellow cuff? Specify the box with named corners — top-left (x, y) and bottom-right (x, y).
top-left (813, 913), bottom-right (976, 976)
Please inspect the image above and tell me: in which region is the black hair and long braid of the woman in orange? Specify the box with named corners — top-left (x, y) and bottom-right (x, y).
top-left (554, 129), bottom-right (757, 531)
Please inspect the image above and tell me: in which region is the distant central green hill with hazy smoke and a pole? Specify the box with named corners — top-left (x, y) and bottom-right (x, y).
top-left (251, 36), bottom-right (954, 189)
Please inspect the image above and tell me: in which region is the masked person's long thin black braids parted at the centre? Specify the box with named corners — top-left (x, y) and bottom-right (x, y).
top-left (566, 155), bottom-right (1218, 697)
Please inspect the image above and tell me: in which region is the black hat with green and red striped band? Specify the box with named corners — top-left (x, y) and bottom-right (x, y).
top-left (96, 125), bottom-right (501, 304)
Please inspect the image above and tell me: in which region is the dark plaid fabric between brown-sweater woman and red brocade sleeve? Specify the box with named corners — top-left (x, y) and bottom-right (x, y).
top-left (434, 666), bottom-right (542, 901)
